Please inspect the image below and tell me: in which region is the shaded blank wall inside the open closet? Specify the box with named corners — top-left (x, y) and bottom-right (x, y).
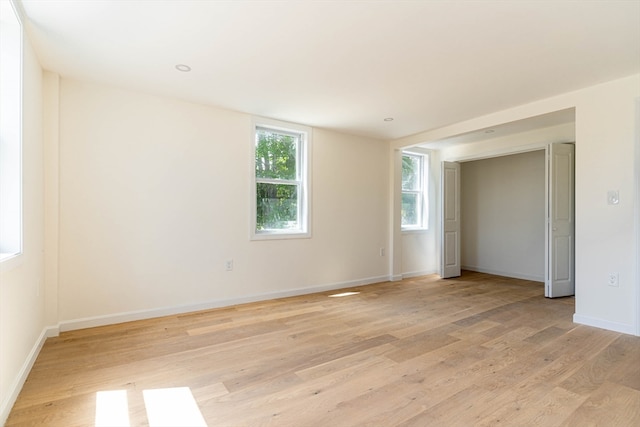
top-left (460, 150), bottom-right (545, 282)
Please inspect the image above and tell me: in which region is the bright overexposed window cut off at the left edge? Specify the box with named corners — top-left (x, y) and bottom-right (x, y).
top-left (0, 1), bottom-right (22, 261)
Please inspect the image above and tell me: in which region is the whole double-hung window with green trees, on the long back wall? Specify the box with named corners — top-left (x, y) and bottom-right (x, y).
top-left (251, 122), bottom-right (310, 239)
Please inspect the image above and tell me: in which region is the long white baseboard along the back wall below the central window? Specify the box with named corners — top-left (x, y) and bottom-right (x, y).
top-left (58, 276), bottom-right (390, 332)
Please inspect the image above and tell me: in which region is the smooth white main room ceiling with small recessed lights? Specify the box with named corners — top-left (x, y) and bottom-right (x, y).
top-left (15, 0), bottom-right (640, 139)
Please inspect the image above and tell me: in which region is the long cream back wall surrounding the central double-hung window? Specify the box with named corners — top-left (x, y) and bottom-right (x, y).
top-left (58, 78), bottom-right (389, 322)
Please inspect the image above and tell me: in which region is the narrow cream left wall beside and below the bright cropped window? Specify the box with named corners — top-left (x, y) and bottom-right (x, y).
top-left (0, 27), bottom-right (45, 424)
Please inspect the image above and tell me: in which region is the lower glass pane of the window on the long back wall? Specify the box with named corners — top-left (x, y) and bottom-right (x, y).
top-left (256, 182), bottom-right (298, 231)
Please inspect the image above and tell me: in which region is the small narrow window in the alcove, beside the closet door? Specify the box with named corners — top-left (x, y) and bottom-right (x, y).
top-left (401, 153), bottom-right (427, 230)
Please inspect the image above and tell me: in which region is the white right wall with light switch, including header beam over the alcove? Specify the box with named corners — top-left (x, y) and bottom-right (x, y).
top-left (392, 74), bottom-right (640, 335)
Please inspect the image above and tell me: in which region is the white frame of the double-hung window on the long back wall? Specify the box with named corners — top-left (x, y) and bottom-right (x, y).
top-left (250, 118), bottom-right (312, 240)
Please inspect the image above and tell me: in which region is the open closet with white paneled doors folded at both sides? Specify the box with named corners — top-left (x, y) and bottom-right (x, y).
top-left (440, 143), bottom-right (575, 298)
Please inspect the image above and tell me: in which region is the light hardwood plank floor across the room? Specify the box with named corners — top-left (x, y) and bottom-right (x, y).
top-left (7, 272), bottom-right (640, 427)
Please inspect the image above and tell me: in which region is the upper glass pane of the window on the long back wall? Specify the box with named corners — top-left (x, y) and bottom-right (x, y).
top-left (256, 129), bottom-right (300, 180)
